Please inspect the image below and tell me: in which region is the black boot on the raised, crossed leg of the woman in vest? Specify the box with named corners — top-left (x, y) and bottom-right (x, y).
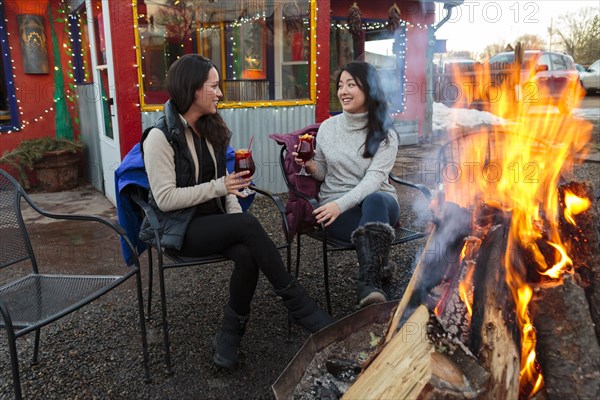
top-left (275, 279), bottom-right (335, 333)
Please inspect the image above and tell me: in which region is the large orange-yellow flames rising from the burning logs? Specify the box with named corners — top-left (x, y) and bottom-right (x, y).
top-left (442, 57), bottom-right (591, 398)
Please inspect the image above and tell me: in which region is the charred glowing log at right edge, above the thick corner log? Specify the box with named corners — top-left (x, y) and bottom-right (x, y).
top-left (559, 182), bottom-right (600, 343)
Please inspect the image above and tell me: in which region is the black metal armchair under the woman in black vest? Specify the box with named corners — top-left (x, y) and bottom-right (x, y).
top-left (122, 185), bottom-right (291, 374)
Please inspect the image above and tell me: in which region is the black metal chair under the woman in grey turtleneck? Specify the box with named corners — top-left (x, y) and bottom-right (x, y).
top-left (279, 145), bottom-right (431, 314)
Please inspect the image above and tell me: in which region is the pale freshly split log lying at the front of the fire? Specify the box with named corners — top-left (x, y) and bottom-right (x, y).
top-left (343, 305), bottom-right (489, 399)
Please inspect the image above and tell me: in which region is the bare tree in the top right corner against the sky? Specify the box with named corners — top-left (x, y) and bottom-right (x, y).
top-left (556, 7), bottom-right (600, 65)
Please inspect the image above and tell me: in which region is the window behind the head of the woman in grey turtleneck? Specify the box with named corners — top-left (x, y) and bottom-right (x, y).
top-left (329, 18), bottom-right (406, 114)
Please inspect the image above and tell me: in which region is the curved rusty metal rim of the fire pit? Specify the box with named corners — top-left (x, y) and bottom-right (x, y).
top-left (271, 300), bottom-right (398, 400)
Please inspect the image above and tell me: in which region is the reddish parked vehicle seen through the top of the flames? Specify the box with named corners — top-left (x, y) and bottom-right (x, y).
top-left (489, 50), bottom-right (580, 114)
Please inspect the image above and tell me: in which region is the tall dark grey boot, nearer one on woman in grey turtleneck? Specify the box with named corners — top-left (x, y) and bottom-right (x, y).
top-left (352, 222), bottom-right (395, 308)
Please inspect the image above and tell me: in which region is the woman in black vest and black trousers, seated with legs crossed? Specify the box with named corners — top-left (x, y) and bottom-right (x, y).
top-left (140, 54), bottom-right (334, 368)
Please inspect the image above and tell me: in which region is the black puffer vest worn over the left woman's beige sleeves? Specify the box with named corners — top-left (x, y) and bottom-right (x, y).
top-left (139, 100), bottom-right (226, 250)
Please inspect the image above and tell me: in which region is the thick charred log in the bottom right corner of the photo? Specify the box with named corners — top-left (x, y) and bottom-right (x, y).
top-left (530, 274), bottom-right (600, 399)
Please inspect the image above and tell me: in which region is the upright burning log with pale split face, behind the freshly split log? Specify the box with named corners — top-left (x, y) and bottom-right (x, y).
top-left (469, 224), bottom-right (521, 399)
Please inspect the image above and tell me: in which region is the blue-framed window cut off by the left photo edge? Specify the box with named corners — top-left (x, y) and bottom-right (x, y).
top-left (0, 3), bottom-right (19, 132)
